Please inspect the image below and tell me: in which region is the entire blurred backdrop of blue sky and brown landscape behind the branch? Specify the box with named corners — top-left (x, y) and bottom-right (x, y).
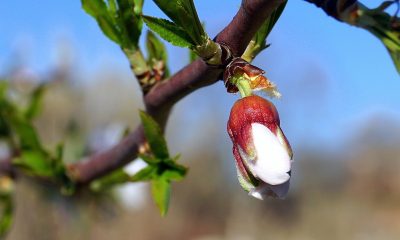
top-left (0, 0), bottom-right (400, 240)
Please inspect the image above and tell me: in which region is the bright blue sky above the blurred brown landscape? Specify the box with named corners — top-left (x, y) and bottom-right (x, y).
top-left (0, 0), bottom-right (400, 150)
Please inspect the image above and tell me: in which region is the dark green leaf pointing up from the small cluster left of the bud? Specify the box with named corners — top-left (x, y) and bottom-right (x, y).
top-left (140, 111), bottom-right (169, 159)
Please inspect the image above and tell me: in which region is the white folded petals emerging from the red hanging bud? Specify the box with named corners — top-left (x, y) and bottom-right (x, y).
top-left (248, 123), bottom-right (291, 185)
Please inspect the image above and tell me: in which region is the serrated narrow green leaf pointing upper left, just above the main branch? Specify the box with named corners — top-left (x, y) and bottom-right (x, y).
top-left (142, 16), bottom-right (195, 48)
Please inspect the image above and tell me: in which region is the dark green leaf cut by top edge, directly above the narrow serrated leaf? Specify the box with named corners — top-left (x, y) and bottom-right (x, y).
top-left (154, 0), bottom-right (209, 45)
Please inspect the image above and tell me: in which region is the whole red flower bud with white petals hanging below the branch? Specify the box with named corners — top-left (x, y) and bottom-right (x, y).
top-left (228, 95), bottom-right (293, 199)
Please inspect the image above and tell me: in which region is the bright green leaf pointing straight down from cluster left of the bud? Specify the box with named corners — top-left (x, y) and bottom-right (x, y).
top-left (151, 177), bottom-right (171, 216)
